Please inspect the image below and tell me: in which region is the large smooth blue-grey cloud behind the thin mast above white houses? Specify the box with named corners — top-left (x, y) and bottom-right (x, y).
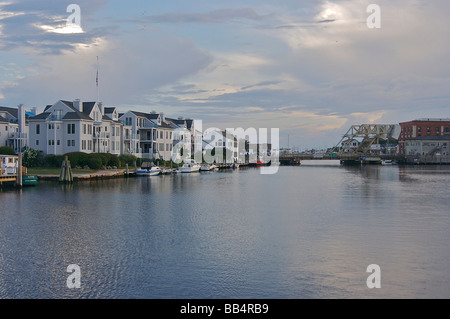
top-left (3, 31), bottom-right (211, 108)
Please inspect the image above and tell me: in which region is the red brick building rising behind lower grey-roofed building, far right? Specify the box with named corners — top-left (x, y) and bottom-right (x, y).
top-left (398, 118), bottom-right (450, 155)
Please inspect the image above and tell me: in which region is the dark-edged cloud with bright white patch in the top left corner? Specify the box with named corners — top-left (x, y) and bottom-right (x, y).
top-left (0, 0), bottom-right (108, 54)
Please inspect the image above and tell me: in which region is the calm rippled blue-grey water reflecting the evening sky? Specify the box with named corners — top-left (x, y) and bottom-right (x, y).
top-left (0, 164), bottom-right (450, 299)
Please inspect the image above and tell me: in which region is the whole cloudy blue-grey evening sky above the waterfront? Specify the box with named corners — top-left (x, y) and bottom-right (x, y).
top-left (0, 0), bottom-right (450, 150)
